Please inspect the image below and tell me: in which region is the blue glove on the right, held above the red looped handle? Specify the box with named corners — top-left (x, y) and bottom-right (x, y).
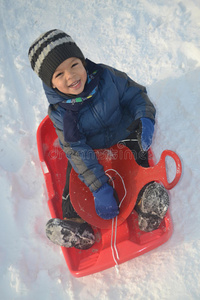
top-left (138, 118), bottom-right (154, 151)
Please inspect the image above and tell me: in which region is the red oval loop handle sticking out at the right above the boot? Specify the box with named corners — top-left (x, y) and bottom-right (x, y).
top-left (156, 150), bottom-right (182, 190)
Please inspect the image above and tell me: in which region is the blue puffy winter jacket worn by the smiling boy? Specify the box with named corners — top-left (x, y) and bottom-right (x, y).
top-left (43, 60), bottom-right (155, 192)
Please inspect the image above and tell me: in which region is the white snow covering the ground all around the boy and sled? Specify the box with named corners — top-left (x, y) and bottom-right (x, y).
top-left (0, 0), bottom-right (200, 300)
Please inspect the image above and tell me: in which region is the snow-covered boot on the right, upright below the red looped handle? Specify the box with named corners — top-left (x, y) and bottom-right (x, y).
top-left (135, 182), bottom-right (169, 232)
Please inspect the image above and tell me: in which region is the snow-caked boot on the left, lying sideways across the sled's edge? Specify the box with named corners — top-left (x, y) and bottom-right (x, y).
top-left (46, 218), bottom-right (95, 250)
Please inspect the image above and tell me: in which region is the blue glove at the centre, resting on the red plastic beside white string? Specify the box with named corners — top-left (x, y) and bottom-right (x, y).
top-left (93, 183), bottom-right (119, 220)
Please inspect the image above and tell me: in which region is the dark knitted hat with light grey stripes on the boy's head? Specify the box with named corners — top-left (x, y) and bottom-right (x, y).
top-left (28, 29), bottom-right (85, 87)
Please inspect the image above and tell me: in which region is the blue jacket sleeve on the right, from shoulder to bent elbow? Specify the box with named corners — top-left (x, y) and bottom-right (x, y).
top-left (103, 65), bottom-right (156, 122)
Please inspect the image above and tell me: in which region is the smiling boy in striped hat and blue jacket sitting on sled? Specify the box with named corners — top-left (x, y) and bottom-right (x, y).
top-left (29, 29), bottom-right (169, 249)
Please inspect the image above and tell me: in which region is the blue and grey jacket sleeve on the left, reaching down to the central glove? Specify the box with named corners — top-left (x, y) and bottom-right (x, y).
top-left (48, 105), bottom-right (109, 192)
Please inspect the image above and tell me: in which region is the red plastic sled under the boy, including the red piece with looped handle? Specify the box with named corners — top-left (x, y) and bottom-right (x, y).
top-left (37, 116), bottom-right (181, 277)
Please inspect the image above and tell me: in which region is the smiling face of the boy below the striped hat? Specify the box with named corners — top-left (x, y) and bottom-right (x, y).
top-left (52, 57), bottom-right (87, 95)
